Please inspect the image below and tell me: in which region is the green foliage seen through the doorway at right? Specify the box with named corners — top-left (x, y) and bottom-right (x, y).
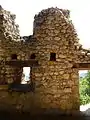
top-left (79, 71), bottom-right (90, 105)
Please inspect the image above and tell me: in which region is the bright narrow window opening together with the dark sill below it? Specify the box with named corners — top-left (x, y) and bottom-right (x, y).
top-left (8, 67), bottom-right (35, 92)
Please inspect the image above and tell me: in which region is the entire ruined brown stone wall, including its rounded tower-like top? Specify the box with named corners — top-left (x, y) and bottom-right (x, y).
top-left (0, 6), bottom-right (90, 111)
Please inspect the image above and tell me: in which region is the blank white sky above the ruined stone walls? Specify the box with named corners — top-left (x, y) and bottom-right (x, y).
top-left (0, 0), bottom-right (90, 48)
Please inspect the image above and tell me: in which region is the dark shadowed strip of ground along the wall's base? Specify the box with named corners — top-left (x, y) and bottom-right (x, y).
top-left (0, 109), bottom-right (90, 120)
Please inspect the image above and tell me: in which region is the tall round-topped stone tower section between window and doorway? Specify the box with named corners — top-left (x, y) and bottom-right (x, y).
top-left (34, 8), bottom-right (79, 110)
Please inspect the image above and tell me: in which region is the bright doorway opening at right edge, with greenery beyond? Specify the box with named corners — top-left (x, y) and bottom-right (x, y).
top-left (79, 70), bottom-right (90, 111)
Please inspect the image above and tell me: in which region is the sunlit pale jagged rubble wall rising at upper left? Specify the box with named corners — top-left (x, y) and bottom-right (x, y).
top-left (0, 6), bottom-right (20, 41)
